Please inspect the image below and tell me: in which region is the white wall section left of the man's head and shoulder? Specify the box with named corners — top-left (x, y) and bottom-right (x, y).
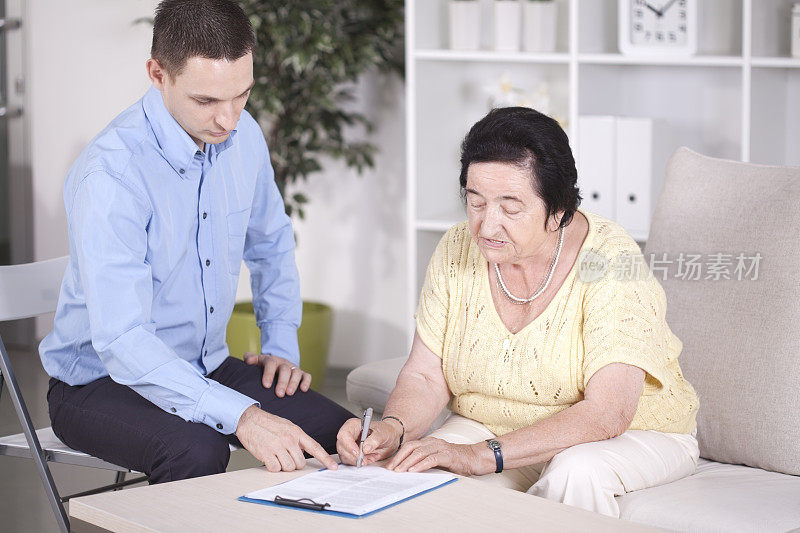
top-left (23, 0), bottom-right (157, 337)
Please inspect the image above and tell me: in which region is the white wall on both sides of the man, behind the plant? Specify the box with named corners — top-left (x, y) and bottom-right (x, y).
top-left (24, 0), bottom-right (409, 367)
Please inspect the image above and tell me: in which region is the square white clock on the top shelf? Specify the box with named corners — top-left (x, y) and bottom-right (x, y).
top-left (629, 0), bottom-right (689, 47)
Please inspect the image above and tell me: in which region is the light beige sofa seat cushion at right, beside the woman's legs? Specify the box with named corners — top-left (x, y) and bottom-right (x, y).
top-left (617, 459), bottom-right (800, 532)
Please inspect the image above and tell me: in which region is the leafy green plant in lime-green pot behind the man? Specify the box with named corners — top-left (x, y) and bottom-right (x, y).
top-left (227, 0), bottom-right (404, 390)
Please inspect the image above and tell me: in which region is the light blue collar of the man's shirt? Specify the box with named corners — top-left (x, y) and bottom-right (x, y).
top-left (142, 86), bottom-right (237, 178)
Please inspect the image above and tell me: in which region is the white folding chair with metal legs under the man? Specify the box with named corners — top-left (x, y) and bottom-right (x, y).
top-left (0, 257), bottom-right (147, 532)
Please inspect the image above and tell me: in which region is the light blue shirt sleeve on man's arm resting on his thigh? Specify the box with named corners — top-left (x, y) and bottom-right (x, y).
top-left (244, 143), bottom-right (303, 365)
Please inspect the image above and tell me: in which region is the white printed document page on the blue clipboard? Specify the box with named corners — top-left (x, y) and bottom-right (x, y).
top-left (245, 465), bottom-right (456, 516)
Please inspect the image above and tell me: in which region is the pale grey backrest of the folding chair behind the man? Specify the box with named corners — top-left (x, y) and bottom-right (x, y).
top-left (0, 256), bottom-right (69, 322)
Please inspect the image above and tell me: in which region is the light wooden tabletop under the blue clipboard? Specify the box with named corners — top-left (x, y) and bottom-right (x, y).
top-left (69, 461), bottom-right (655, 533)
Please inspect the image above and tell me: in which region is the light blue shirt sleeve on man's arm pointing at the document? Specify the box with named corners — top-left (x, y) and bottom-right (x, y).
top-left (67, 171), bottom-right (258, 434)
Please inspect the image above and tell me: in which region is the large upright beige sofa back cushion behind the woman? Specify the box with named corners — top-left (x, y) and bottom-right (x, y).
top-left (645, 148), bottom-right (800, 476)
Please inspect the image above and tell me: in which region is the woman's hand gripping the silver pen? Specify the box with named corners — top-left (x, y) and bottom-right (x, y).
top-left (336, 418), bottom-right (402, 466)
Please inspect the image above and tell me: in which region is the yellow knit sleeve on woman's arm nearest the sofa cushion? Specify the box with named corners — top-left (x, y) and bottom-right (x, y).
top-left (583, 250), bottom-right (670, 394)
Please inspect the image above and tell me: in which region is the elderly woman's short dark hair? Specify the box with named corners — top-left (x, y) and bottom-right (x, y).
top-left (459, 107), bottom-right (581, 226)
